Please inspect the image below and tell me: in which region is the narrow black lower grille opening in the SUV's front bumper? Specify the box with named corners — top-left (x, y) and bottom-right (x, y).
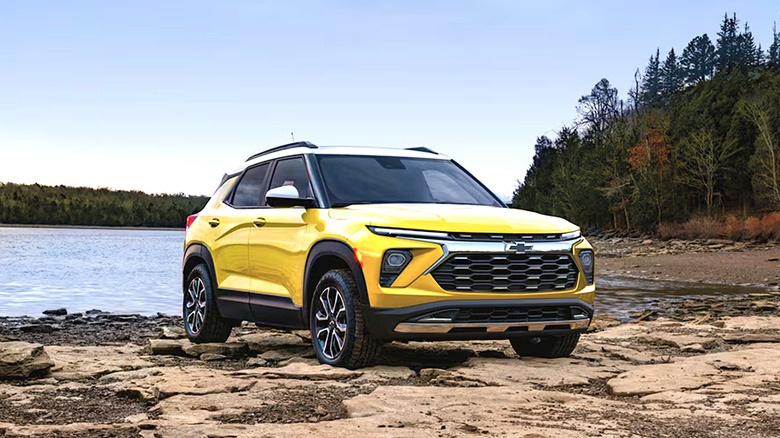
top-left (452, 306), bottom-right (572, 323)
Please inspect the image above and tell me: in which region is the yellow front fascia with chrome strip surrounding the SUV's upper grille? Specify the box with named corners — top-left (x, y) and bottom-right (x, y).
top-left (351, 228), bottom-right (596, 308)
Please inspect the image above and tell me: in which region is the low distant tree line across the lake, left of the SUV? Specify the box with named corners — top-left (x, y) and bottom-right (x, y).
top-left (0, 183), bottom-right (208, 228)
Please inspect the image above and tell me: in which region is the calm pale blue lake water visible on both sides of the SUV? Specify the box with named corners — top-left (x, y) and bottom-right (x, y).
top-left (0, 227), bottom-right (756, 316)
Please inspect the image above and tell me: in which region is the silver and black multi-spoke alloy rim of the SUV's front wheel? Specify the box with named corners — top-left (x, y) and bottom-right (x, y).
top-left (314, 286), bottom-right (347, 360)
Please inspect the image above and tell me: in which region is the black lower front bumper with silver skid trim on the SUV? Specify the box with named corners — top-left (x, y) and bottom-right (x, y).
top-left (362, 299), bottom-right (593, 341)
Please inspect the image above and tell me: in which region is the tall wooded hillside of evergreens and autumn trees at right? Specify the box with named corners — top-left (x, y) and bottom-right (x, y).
top-left (512, 14), bottom-right (780, 231)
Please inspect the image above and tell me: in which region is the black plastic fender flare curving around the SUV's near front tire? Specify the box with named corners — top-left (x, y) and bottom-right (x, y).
top-left (303, 240), bottom-right (370, 326)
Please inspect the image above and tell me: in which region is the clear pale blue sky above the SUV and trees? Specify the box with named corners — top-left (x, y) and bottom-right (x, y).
top-left (0, 0), bottom-right (780, 198)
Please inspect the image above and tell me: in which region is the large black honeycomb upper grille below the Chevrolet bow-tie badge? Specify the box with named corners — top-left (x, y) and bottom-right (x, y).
top-left (431, 254), bottom-right (579, 292)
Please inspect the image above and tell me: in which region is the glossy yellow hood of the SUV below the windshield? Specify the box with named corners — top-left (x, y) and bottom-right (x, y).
top-left (329, 204), bottom-right (577, 234)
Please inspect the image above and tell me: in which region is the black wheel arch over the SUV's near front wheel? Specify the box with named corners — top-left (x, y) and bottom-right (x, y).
top-left (303, 240), bottom-right (369, 326)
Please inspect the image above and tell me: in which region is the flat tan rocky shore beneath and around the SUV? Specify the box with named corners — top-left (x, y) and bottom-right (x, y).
top-left (0, 239), bottom-right (780, 438)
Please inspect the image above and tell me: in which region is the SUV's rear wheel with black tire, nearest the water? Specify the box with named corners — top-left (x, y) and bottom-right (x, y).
top-left (182, 264), bottom-right (233, 344)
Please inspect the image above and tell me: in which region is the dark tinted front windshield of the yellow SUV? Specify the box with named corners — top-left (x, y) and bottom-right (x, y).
top-left (317, 155), bottom-right (501, 207)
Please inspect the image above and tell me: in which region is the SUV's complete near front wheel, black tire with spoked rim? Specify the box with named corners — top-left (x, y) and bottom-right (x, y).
top-left (309, 269), bottom-right (382, 369)
